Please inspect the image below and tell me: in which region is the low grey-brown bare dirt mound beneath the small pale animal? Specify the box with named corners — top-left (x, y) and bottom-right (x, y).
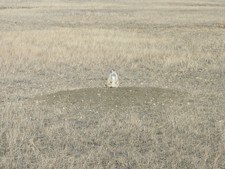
top-left (34, 87), bottom-right (187, 107)
